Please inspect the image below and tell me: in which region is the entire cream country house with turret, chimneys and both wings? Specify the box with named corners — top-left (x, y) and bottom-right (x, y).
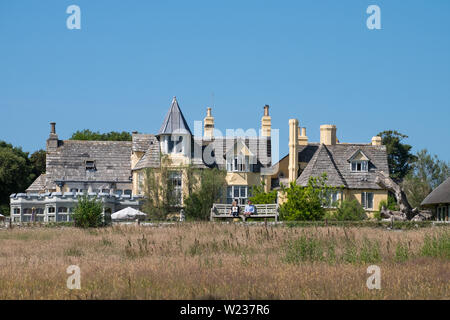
top-left (10, 97), bottom-right (389, 222)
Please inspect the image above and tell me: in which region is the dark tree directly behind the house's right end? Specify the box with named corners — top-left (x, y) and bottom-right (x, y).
top-left (378, 130), bottom-right (416, 182)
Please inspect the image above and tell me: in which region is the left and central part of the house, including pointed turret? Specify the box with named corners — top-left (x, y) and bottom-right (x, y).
top-left (10, 97), bottom-right (272, 222)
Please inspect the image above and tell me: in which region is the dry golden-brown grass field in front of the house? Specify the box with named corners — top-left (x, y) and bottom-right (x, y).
top-left (0, 223), bottom-right (450, 299)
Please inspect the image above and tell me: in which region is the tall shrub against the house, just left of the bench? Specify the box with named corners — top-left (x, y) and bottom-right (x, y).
top-left (184, 168), bottom-right (226, 220)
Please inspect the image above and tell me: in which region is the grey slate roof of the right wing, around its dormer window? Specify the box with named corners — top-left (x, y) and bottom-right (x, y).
top-left (297, 144), bottom-right (389, 190)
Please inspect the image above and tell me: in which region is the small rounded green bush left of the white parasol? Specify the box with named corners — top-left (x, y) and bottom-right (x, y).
top-left (73, 194), bottom-right (103, 228)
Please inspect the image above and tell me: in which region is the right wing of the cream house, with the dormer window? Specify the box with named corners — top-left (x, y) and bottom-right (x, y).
top-left (270, 119), bottom-right (389, 215)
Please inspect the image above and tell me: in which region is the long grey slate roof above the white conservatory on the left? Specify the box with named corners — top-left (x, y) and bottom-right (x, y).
top-left (46, 140), bottom-right (132, 188)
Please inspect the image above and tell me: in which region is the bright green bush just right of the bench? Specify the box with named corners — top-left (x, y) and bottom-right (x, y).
top-left (280, 174), bottom-right (335, 221)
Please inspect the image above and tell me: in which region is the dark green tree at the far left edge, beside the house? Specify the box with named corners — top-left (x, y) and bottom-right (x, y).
top-left (0, 141), bottom-right (33, 215)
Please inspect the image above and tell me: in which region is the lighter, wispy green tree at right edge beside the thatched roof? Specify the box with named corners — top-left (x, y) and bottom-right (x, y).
top-left (402, 149), bottom-right (450, 208)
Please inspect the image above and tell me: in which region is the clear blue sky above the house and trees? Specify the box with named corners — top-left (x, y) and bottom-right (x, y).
top-left (0, 0), bottom-right (450, 160)
